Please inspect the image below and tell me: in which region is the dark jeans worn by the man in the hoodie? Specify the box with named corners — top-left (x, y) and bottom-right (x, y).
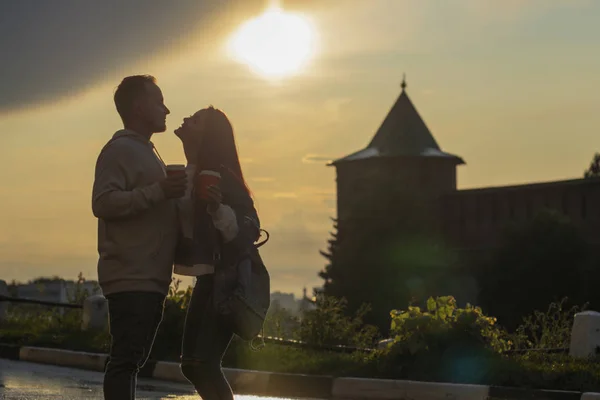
top-left (104, 292), bottom-right (165, 400)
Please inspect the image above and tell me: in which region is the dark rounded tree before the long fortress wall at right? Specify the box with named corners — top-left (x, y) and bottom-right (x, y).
top-left (479, 210), bottom-right (590, 329)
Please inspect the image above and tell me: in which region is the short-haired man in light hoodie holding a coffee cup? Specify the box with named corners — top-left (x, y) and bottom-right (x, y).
top-left (92, 75), bottom-right (189, 400)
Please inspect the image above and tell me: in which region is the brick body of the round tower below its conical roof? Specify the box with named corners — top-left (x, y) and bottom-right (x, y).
top-left (336, 157), bottom-right (456, 238)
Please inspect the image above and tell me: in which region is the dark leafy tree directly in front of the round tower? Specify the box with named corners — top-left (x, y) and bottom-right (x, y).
top-left (319, 207), bottom-right (451, 333)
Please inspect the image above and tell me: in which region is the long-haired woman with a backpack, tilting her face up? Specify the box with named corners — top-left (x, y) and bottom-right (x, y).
top-left (175, 106), bottom-right (260, 400)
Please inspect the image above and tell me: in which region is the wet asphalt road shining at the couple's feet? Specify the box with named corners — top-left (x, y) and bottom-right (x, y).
top-left (0, 359), bottom-right (318, 400)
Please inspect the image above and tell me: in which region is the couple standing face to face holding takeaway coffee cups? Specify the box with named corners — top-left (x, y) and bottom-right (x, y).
top-left (92, 75), bottom-right (259, 400)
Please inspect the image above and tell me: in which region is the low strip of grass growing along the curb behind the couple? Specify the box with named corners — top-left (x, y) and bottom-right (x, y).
top-left (0, 323), bottom-right (600, 391)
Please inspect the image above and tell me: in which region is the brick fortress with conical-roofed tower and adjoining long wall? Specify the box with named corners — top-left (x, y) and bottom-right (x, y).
top-left (329, 76), bottom-right (600, 296)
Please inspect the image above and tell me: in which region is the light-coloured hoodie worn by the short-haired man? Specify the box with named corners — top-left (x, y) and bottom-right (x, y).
top-left (92, 129), bottom-right (194, 295)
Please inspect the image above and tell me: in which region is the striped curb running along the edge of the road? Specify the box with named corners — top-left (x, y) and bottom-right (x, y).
top-left (0, 343), bottom-right (600, 400)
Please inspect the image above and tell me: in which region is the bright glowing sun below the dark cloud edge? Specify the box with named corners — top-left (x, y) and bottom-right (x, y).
top-left (228, 6), bottom-right (315, 78)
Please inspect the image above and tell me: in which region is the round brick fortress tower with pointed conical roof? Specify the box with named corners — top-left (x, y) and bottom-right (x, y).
top-left (330, 79), bottom-right (464, 241)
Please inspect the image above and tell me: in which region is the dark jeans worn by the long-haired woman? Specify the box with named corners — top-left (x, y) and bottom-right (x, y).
top-left (181, 274), bottom-right (233, 400)
